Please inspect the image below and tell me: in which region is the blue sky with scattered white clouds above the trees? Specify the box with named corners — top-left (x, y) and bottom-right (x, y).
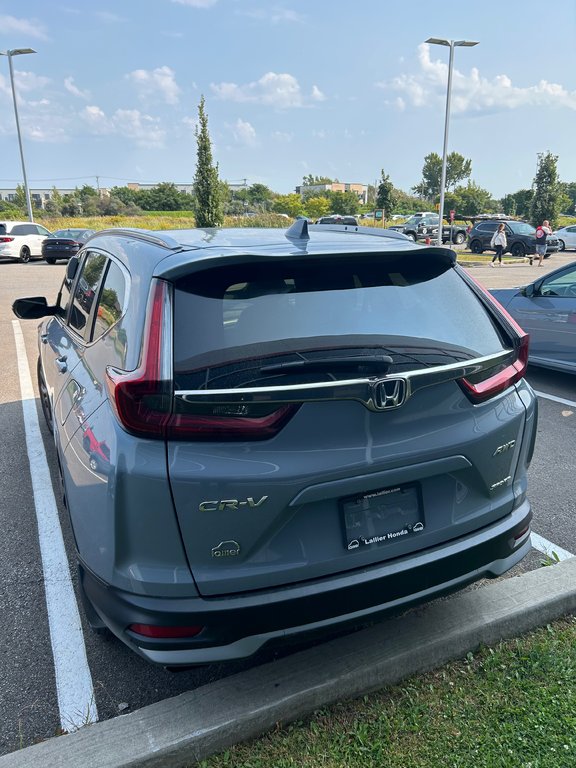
top-left (0, 0), bottom-right (576, 198)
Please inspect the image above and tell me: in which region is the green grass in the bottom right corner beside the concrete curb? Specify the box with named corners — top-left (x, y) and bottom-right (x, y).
top-left (200, 618), bottom-right (576, 768)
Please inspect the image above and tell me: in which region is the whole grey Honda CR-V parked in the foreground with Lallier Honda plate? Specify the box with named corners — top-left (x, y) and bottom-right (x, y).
top-left (14, 220), bottom-right (537, 666)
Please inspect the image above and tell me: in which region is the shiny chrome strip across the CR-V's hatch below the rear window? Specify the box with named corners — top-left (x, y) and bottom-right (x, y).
top-left (174, 350), bottom-right (515, 412)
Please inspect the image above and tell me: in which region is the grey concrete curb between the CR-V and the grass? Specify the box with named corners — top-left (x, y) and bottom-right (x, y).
top-left (0, 558), bottom-right (576, 768)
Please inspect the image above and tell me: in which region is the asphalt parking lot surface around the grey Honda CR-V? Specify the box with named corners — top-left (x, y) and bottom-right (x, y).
top-left (0, 253), bottom-right (576, 760)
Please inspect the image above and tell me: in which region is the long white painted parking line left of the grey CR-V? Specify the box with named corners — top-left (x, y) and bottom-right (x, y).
top-left (12, 320), bottom-right (98, 731)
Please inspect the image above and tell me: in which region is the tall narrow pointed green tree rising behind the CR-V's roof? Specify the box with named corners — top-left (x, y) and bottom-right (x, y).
top-left (194, 96), bottom-right (224, 227)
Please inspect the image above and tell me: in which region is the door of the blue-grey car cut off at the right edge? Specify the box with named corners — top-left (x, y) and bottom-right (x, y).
top-left (507, 264), bottom-right (576, 371)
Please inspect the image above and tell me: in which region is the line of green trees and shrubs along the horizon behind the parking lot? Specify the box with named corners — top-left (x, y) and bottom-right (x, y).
top-left (0, 96), bottom-right (576, 227)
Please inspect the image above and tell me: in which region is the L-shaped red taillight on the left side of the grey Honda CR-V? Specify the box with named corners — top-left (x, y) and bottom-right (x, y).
top-left (106, 280), bottom-right (299, 440)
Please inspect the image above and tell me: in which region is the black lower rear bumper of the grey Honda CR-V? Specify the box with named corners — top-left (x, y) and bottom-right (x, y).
top-left (80, 501), bottom-right (532, 666)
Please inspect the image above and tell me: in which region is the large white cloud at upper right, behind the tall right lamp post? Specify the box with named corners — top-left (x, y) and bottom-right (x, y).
top-left (377, 43), bottom-right (576, 114)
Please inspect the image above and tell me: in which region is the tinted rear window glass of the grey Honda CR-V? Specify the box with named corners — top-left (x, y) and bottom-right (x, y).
top-left (174, 251), bottom-right (506, 389)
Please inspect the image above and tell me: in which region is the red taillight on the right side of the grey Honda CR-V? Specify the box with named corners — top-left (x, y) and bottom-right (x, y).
top-left (458, 278), bottom-right (530, 403)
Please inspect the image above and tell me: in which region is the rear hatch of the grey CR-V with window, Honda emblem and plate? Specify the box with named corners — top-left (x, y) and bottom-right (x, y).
top-left (113, 249), bottom-right (526, 596)
